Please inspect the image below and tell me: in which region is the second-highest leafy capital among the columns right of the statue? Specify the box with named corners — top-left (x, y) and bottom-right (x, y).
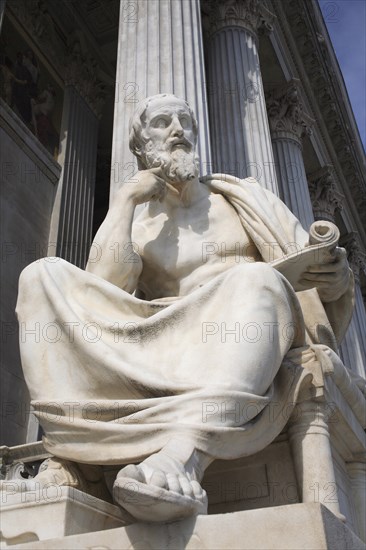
top-left (266, 78), bottom-right (314, 143)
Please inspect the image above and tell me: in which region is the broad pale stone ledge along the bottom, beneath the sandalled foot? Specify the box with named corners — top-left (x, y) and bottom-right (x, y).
top-left (3, 504), bottom-right (366, 550)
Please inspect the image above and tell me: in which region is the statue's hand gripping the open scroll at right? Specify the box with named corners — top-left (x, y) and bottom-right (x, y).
top-left (299, 247), bottom-right (350, 303)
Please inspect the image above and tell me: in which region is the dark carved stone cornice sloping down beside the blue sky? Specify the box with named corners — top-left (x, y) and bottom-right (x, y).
top-left (278, 0), bottom-right (366, 234)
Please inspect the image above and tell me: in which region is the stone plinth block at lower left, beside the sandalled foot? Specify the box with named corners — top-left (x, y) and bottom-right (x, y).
top-left (0, 488), bottom-right (130, 548)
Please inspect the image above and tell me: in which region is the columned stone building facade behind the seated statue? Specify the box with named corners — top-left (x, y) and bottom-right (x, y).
top-left (0, 0), bottom-right (366, 548)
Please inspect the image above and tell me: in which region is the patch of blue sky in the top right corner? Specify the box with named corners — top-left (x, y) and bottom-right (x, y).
top-left (319, 0), bottom-right (366, 149)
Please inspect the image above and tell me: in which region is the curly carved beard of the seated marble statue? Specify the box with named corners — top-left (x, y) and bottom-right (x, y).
top-left (144, 141), bottom-right (199, 185)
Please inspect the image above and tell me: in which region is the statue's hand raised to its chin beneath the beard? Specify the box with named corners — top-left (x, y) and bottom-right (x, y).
top-left (121, 168), bottom-right (166, 205)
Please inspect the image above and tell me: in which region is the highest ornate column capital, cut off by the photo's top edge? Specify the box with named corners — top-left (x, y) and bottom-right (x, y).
top-left (202, 0), bottom-right (276, 36)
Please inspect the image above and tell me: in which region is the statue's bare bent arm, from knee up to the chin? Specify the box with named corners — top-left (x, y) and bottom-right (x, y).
top-left (85, 168), bottom-right (165, 293)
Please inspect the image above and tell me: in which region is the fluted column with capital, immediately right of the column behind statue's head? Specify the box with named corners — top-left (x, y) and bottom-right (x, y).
top-left (203, 0), bottom-right (278, 195)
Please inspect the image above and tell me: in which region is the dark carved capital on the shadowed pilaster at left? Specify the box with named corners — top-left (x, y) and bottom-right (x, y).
top-left (64, 36), bottom-right (110, 118)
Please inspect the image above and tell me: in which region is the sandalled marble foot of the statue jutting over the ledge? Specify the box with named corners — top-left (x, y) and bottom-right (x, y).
top-left (113, 441), bottom-right (212, 521)
